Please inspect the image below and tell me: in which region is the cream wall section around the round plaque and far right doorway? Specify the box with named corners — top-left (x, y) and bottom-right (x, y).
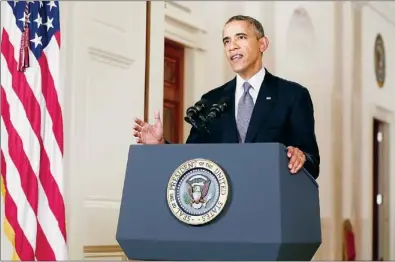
top-left (360, 2), bottom-right (395, 259)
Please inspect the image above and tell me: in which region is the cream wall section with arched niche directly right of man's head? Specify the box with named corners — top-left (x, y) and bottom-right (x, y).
top-left (269, 1), bottom-right (339, 259)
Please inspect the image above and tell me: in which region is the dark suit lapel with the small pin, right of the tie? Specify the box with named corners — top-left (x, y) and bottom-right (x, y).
top-left (245, 70), bottom-right (277, 143)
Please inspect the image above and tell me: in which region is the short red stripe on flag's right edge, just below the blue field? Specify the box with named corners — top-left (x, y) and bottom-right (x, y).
top-left (38, 52), bottom-right (63, 155)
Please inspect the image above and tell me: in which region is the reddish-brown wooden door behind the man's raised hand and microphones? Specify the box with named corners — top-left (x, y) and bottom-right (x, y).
top-left (163, 39), bottom-right (184, 143)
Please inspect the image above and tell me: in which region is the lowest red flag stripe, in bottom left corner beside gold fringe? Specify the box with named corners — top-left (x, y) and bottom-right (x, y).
top-left (1, 151), bottom-right (34, 261)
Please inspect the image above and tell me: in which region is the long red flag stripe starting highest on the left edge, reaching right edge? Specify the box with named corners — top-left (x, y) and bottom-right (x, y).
top-left (2, 31), bottom-right (66, 244)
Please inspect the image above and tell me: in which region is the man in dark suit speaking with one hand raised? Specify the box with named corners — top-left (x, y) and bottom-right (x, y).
top-left (134, 16), bottom-right (320, 178)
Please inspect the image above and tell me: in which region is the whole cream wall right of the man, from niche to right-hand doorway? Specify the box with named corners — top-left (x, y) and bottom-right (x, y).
top-left (269, 2), bottom-right (395, 260)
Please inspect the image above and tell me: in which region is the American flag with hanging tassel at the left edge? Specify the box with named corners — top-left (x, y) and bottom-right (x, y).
top-left (1, 1), bottom-right (67, 260)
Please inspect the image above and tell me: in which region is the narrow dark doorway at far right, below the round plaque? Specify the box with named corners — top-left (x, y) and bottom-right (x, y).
top-left (372, 118), bottom-right (390, 261)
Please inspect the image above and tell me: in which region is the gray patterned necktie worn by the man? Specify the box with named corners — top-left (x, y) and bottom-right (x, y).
top-left (236, 82), bottom-right (254, 143)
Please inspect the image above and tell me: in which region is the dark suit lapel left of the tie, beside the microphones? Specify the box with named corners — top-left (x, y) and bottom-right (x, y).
top-left (221, 78), bottom-right (239, 143)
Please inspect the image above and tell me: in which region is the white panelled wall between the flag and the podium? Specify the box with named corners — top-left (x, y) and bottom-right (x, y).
top-left (61, 1), bottom-right (146, 260)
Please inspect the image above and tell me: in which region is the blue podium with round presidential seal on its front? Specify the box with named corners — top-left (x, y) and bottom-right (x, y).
top-left (116, 143), bottom-right (321, 261)
